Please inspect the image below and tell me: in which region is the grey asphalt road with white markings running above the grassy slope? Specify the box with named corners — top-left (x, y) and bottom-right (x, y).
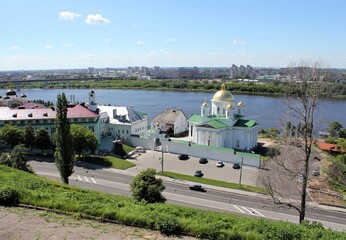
top-left (29, 158), bottom-right (346, 231)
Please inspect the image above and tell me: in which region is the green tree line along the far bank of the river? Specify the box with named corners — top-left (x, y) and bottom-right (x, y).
top-left (13, 79), bottom-right (346, 97)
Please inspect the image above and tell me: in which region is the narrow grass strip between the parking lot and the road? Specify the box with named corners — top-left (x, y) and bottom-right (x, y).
top-left (163, 171), bottom-right (266, 194)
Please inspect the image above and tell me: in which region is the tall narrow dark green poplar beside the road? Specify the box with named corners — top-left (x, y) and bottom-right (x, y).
top-left (54, 93), bottom-right (74, 184)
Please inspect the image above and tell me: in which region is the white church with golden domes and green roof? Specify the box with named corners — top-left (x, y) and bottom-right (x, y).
top-left (188, 83), bottom-right (258, 151)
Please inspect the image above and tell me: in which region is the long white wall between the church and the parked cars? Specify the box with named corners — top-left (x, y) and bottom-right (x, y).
top-left (131, 137), bottom-right (260, 168)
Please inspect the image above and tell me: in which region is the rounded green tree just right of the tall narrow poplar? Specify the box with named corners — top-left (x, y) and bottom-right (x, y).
top-left (71, 124), bottom-right (98, 157)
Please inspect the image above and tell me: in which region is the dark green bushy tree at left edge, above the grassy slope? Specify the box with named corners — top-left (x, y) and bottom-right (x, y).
top-left (0, 144), bottom-right (33, 172)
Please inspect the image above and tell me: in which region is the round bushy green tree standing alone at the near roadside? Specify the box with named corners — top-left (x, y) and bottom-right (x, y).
top-left (130, 168), bottom-right (166, 203)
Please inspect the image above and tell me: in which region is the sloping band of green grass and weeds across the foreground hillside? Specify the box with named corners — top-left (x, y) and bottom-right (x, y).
top-left (0, 165), bottom-right (346, 240)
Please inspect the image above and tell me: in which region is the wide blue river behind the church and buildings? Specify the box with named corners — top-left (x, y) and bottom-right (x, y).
top-left (12, 89), bottom-right (346, 130)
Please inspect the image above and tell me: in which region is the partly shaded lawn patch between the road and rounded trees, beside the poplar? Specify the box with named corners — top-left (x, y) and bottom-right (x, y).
top-left (80, 155), bottom-right (136, 170)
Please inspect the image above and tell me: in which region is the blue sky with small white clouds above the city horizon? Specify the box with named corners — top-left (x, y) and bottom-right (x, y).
top-left (0, 0), bottom-right (346, 71)
